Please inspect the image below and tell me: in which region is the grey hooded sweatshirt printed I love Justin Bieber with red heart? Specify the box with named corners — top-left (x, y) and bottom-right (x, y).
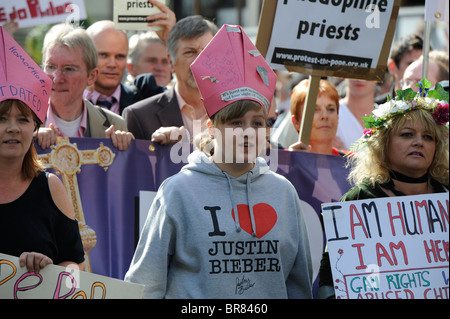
top-left (125, 151), bottom-right (312, 299)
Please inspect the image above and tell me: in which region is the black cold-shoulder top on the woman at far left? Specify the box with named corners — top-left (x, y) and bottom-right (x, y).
top-left (0, 172), bottom-right (84, 264)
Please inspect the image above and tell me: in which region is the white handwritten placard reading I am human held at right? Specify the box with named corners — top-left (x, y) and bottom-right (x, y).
top-left (322, 193), bottom-right (449, 299)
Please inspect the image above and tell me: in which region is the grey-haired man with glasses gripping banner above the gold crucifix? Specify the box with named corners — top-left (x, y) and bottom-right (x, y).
top-left (38, 24), bottom-right (134, 151)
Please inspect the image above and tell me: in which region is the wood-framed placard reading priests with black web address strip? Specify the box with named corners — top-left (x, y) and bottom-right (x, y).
top-left (256, 0), bottom-right (399, 81)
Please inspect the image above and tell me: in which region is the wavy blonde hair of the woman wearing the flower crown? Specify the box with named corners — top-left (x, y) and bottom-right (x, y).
top-left (348, 108), bottom-right (449, 185)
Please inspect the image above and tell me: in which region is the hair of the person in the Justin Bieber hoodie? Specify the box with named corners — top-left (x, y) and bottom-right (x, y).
top-left (193, 100), bottom-right (267, 156)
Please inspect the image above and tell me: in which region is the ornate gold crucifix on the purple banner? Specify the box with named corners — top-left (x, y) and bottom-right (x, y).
top-left (38, 137), bottom-right (116, 272)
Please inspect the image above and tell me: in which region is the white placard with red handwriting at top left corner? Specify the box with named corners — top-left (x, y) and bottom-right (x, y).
top-left (0, 0), bottom-right (87, 28)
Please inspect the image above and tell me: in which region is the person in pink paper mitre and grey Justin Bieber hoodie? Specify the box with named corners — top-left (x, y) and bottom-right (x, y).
top-left (125, 25), bottom-right (312, 299)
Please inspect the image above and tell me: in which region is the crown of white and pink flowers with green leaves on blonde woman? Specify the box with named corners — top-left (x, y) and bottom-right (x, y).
top-left (350, 78), bottom-right (449, 152)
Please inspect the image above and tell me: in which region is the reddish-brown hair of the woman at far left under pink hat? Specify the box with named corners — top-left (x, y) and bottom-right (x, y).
top-left (0, 99), bottom-right (44, 179)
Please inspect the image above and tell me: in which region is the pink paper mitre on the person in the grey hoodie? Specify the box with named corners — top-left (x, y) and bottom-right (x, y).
top-left (191, 25), bottom-right (277, 117)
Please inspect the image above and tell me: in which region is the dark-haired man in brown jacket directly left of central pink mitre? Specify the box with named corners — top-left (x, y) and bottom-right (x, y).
top-left (123, 16), bottom-right (217, 144)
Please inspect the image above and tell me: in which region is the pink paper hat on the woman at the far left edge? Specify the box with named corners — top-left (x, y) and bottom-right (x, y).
top-left (0, 27), bottom-right (52, 122)
